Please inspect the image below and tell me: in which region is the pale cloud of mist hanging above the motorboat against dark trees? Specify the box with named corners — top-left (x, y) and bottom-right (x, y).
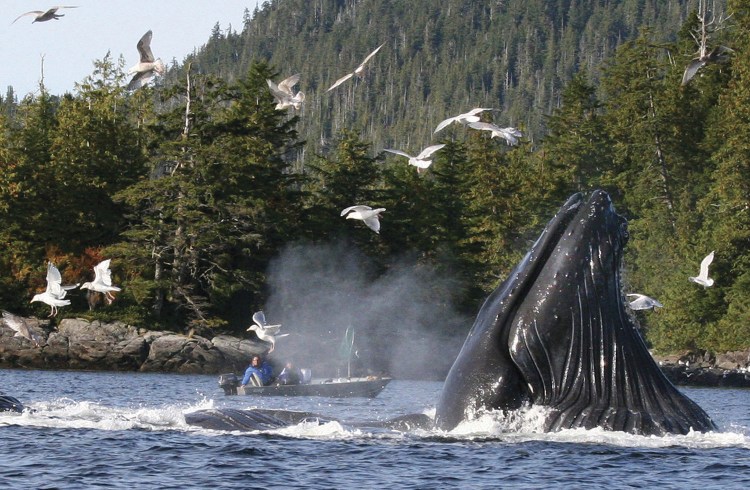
top-left (265, 242), bottom-right (473, 379)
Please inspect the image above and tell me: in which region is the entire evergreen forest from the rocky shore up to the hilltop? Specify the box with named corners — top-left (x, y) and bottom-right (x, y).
top-left (0, 0), bottom-right (750, 376)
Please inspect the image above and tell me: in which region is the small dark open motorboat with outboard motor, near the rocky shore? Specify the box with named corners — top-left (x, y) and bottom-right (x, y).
top-left (219, 369), bottom-right (392, 398)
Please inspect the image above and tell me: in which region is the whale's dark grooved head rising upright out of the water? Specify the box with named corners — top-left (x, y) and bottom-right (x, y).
top-left (435, 191), bottom-right (716, 435)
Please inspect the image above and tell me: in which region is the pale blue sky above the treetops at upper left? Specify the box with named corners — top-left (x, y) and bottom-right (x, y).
top-left (0, 0), bottom-right (263, 100)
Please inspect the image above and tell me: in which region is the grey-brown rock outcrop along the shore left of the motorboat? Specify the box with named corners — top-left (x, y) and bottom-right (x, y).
top-left (0, 318), bottom-right (267, 374)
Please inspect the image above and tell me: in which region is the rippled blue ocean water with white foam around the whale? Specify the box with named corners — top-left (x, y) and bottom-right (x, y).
top-left (0, 370), bottom-right (750, 489)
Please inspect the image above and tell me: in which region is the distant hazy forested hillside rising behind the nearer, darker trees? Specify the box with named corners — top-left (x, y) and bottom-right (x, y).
top-left (181, 0), bottom-right (725, 151)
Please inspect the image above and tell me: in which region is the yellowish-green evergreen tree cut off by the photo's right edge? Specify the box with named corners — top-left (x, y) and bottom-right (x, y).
top-left (693, 0), bottom-right (750, 350)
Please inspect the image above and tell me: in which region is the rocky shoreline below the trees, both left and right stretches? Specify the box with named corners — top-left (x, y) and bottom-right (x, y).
top-left (0, 318), bottom-right (750, 388)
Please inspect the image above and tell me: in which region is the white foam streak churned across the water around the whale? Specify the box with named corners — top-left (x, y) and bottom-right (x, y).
top-left (0, 398), bottom-right (750, 449)
